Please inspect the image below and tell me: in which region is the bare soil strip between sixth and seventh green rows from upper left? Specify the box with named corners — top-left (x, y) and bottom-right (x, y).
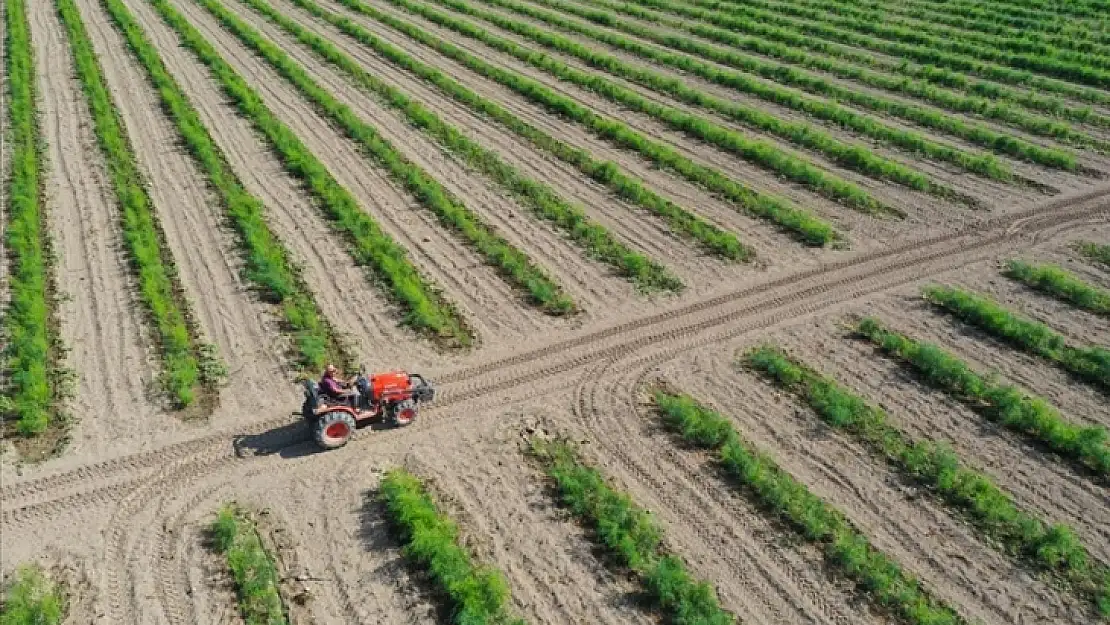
top-left (256, 0), bottom-right (803, 293)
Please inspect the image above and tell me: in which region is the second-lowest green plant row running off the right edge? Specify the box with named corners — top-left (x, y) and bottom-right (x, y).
top-left (855, 317), bottom-right (1110, 477)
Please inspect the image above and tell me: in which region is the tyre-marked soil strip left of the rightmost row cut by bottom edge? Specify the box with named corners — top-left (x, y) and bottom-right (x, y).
top-left (574, 359), bottom-right (878, 625)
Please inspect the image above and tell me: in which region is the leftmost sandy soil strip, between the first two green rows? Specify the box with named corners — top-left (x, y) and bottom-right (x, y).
top-left (25, 1), bottom-right (162, 457)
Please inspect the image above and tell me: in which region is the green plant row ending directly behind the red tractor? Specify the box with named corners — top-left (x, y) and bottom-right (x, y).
top-left (101, 0), bottom-right (351, 372)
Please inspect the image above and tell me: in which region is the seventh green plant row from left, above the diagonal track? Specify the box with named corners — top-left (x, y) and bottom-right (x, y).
top-left (282, 0), bottom-right (755, 261)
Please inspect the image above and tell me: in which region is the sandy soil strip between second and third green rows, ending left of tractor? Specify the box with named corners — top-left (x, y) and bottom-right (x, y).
top-left (78, 0), bottom-right (292, 435)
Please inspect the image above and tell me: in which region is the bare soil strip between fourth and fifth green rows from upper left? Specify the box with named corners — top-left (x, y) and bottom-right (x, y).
top-left (163, 0), bottom-right (566, 341)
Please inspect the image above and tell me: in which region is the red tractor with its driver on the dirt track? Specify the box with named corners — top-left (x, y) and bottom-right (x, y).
top-left (301, 371), bottom-right (435, 450)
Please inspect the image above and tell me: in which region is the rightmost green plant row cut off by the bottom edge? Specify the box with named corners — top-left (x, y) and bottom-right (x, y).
top-left (653, 389), bottom-right (966, 625)
